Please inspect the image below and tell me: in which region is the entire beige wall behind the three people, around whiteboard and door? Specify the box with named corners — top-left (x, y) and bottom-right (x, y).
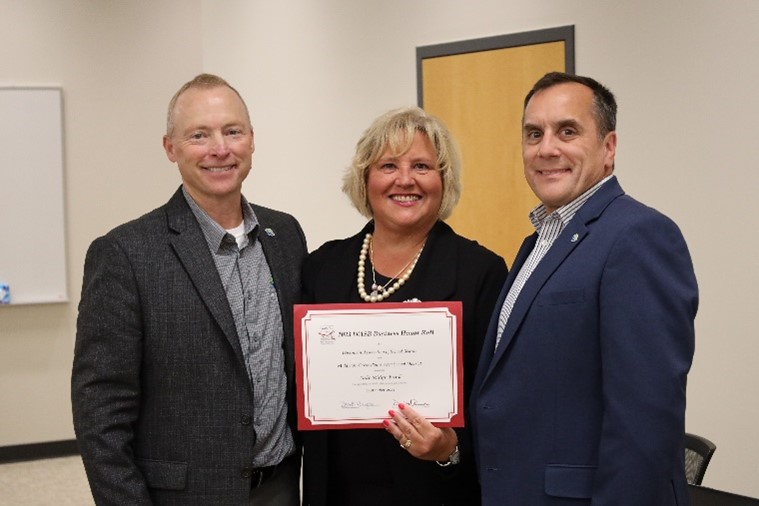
top-left (0, 0), bottom-right (759, 496)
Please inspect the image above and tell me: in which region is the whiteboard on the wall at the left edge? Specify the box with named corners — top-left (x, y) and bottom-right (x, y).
top-left (0, 88), bottom-right (68, 304)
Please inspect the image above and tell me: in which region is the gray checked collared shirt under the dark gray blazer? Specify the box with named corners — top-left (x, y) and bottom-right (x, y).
top-left (182, 187), bottom-right (295, 467)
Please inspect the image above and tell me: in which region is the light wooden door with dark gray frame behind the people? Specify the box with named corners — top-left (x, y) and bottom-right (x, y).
top-left (417, 27), bottom-right (574, 265)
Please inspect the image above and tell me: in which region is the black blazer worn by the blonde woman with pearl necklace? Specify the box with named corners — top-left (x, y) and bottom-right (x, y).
top-left (302, 222), bottom-right (507, 506)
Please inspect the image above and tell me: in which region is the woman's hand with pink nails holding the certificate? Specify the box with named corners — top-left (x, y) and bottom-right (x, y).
top-left (382, 403), bottom-right (458, 462)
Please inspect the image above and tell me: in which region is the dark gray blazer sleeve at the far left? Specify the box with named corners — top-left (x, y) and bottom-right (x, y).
top-left (71, 237), bottom-right (151, 505)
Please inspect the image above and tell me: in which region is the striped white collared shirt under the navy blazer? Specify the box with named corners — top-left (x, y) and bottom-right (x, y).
top-left (495, 175), bottom-right (611, 348)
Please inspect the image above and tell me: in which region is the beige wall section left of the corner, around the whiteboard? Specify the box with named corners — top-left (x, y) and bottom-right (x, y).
top-left (0, 0), bottom-right (203, 446)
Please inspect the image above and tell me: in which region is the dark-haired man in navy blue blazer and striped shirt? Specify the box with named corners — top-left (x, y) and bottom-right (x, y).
top-left (470, 73), bottom-right (698, 506)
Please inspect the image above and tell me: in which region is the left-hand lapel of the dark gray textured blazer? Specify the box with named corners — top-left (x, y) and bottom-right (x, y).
top-left (166, 189), bottom-right (243, 362)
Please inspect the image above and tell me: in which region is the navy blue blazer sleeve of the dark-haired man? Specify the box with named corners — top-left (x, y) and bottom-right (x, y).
top-left (593, 214), bottom-right (698, 505)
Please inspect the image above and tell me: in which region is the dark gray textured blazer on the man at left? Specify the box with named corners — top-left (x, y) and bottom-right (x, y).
top-left (72, 189), bottom-right (306, 505)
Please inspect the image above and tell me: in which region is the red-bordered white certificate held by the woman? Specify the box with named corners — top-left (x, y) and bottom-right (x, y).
top-left (294, 302), bottom-right (464, 430)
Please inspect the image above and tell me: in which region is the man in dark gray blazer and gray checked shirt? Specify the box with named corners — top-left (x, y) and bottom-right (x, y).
top-left (72, 74), bottom-right (306, 506)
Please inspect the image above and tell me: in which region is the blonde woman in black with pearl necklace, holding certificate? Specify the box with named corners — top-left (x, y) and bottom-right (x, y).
top-left (302, 107), bottom-right (507, 506)
